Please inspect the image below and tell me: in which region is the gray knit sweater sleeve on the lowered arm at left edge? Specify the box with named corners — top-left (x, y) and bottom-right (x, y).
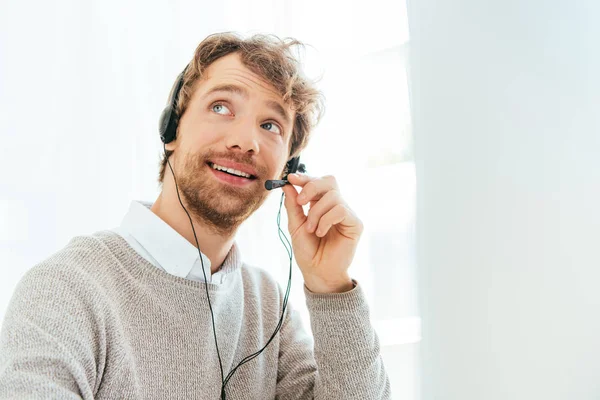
top-left (0, 265), bottom-right (102, 399)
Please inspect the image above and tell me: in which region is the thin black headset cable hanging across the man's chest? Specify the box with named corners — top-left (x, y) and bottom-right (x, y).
top-left (163, 143), bottom-right (294, 400)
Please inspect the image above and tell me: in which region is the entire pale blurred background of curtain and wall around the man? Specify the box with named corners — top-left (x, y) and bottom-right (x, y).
top-left (0, 0), bottom-right (600, 400)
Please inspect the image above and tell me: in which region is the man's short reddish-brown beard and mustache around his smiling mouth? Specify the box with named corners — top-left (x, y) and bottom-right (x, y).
top-left (176, 151), bottom-right (269, 236)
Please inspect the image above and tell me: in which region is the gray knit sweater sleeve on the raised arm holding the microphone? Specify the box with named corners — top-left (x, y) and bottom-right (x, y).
top-left (277, 281), bottom-right (391, 400)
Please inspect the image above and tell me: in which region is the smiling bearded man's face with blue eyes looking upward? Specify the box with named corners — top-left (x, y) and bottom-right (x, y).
top-left (166, 53), bottom-right (294, 234)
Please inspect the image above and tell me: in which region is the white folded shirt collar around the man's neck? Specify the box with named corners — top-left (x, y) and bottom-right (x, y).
top-left (121, 200), bottom-right (240, 282)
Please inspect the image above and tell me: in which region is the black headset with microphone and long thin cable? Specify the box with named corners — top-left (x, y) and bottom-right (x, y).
top-left (158, 66), bottom-right (306, 400)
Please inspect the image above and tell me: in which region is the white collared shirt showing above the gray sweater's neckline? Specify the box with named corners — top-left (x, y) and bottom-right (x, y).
top-left (110, 200), bottom-right (226, 285)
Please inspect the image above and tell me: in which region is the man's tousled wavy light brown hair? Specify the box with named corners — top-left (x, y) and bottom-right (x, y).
top-left (158, 32), bottom-right (324, 184)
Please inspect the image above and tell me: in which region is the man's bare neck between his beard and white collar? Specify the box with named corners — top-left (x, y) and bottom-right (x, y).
top-left (151, 188), bottom-right (235, 274)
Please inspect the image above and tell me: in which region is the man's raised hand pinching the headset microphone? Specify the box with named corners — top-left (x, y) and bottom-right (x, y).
top-left (283, 174), bottom-right (363, 293)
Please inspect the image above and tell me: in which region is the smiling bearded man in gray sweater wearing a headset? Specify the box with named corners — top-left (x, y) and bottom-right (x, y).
top-left (0, 34), bottom-right (390, 400)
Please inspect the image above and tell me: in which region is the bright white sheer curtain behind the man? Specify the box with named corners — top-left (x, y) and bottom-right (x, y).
top-left (0, 0), bottom-right (412, 399)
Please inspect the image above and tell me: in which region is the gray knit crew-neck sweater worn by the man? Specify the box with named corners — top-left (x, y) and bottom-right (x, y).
top-left (0, 231), bottom-right (391, 400)
